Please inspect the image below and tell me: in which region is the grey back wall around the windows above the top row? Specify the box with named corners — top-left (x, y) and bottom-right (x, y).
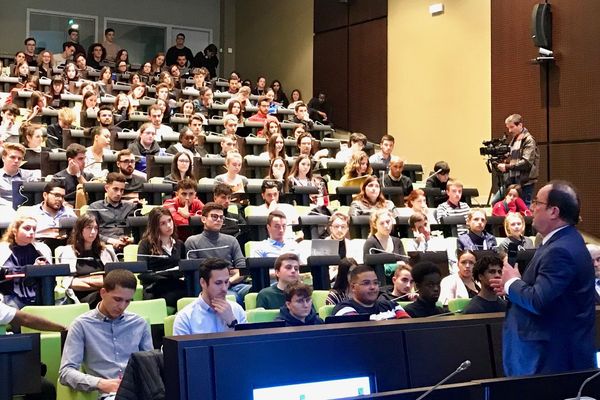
top-left (0, 0), bottom-right (221, 58)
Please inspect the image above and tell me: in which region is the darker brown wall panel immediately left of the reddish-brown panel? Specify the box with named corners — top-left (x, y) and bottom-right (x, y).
top-left (312, 27), bottom-right (349, 129)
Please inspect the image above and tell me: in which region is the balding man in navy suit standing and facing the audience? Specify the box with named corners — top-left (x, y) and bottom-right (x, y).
top-left (493, 181), bottom-right (596, 376)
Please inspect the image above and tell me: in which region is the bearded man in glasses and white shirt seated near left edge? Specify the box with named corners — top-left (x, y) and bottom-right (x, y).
top-left (27, 181), bottom-right (76, 240)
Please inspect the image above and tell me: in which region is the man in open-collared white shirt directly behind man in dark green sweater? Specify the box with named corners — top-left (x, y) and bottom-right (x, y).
top-left (252, 210), bottom-right (300, 258)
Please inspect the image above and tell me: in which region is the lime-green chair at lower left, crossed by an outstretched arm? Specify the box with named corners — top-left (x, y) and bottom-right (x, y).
top-left (21, 303), bottom-right (90, 390)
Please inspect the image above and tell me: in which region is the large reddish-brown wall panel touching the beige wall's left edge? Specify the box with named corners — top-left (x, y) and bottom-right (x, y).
top-left (348, 18), bottom-right (387, 143)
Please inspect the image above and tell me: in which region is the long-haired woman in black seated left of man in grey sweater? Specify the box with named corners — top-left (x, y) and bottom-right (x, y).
top-left (138, 207), bottom-right (186, 307)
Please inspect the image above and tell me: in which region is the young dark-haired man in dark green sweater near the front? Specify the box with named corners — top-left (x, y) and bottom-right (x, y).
top-left (256, 253), bottom-right (300, 310)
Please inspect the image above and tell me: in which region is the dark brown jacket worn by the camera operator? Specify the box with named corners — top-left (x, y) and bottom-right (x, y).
top-left (508, 128), bottom-right (540, 186)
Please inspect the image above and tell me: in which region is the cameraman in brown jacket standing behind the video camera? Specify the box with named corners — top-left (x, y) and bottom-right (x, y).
top-left (492, 114), bottom-right (540, 207)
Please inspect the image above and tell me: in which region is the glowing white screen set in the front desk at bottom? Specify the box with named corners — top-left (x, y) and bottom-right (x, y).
top-left (252, 376), bottom-right (373, 400)
